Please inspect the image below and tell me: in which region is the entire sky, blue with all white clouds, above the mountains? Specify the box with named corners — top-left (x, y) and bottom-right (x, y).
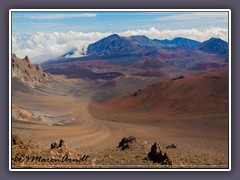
top-left (12, 11), bottom-right (228, 63)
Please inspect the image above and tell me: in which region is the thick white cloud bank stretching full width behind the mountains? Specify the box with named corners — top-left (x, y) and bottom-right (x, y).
top-left (12, 27), bottom-right (228, 63)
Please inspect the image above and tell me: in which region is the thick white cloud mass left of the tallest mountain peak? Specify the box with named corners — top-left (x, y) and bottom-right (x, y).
top-left (12, 31), bottom-right (111, 63)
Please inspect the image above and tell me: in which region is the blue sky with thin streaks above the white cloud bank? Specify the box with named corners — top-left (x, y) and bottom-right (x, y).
top-left (12, 12), bottom-right (228, 33)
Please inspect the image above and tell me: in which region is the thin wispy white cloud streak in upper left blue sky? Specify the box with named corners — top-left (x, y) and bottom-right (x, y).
top-left (13, 13), bottom-right (96, 19)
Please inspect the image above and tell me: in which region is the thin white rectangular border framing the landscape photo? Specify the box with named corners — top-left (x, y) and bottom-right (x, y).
top-left (9, 9), bottom-right (231, 171)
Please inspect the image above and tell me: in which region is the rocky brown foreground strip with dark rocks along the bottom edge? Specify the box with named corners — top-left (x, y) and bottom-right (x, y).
top-left (11, 134), bottom-right (228, 169)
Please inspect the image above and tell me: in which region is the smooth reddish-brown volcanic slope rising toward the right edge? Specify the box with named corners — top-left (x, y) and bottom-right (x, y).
top-left (90, 71), bottom-right (228, 117)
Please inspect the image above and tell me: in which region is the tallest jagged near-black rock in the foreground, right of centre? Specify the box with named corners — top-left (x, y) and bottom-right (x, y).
top-left (148, 143), bottom-right (172, 165)
